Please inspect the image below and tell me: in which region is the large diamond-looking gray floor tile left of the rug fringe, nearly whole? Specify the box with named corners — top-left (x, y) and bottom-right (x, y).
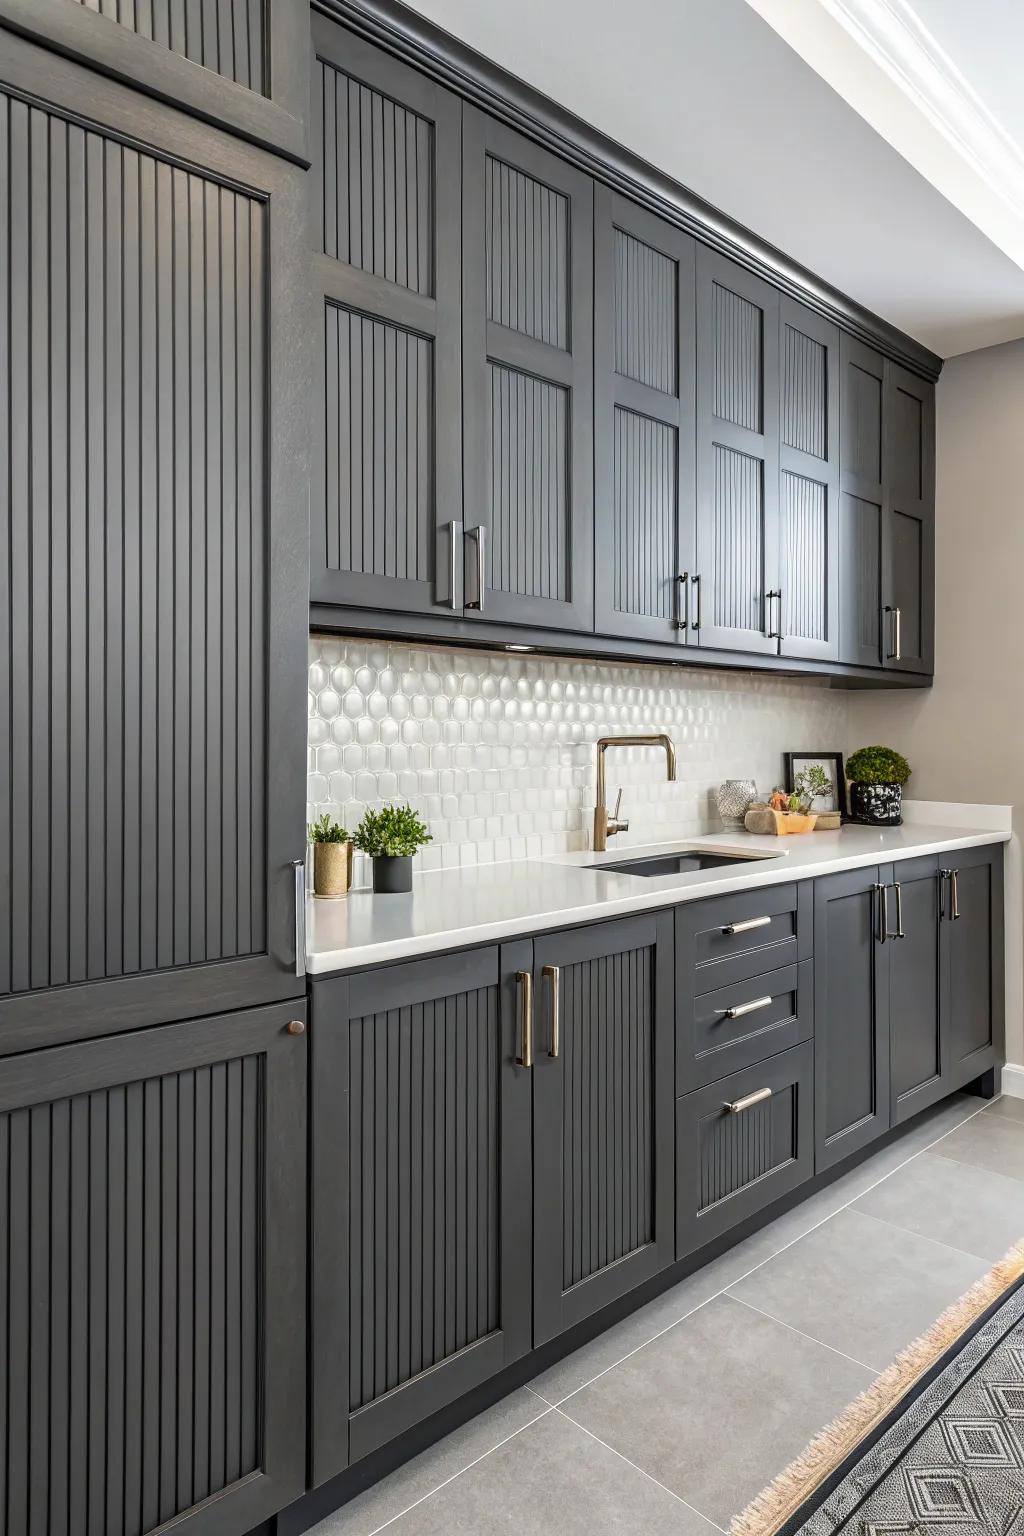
top-left (562, 1296), bottom-right (872, 1530)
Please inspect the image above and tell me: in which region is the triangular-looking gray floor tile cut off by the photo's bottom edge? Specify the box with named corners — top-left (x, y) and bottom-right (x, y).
top-left (373, 1412), bottom-right (715, 1536)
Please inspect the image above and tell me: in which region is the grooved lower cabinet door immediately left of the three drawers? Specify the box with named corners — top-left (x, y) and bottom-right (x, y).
top-left (533, 912), bottom-right (676, 1346)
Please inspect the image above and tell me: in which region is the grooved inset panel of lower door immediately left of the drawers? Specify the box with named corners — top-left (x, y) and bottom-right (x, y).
top-left (560, 948), bottom-right (654, 1290)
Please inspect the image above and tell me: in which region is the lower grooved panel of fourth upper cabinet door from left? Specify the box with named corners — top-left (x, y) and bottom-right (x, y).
top-left (709, 442), bottom-right (765, 630)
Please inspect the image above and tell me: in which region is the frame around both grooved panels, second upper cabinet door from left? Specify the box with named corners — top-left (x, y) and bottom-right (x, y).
top-left (462, 103), bottom-right (594, 633)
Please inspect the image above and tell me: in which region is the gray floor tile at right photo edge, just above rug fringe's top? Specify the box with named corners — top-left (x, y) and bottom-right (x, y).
top-left (852, 1141), bottom-right (1024, 1263)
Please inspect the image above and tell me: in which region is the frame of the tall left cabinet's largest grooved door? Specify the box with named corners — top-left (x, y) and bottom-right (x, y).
top-left (0, 38), bottom-right (310, 1054)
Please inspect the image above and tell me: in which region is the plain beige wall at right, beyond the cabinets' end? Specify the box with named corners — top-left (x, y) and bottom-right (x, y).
top-left (849, 341), bottom-right (1024, 1064)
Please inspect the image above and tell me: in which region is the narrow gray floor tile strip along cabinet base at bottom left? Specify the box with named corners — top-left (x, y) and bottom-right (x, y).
top-left (310, 1387), bottom-right (547, 1536)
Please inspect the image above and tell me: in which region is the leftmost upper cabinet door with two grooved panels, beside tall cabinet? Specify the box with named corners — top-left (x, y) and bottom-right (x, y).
top-left (310, 15), bottom-right (462, 613)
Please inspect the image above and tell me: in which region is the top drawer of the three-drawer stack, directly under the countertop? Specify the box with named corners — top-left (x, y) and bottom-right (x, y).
top-left (676, 880), bottom-right (811, 997)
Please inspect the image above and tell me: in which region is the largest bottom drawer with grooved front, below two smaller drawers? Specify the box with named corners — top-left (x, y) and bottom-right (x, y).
top-left (676, 1040), bottom-right (814, 1258)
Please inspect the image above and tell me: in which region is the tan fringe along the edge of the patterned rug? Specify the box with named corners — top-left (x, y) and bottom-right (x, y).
top-left (729, 1238), bottom-right (1024, 1536)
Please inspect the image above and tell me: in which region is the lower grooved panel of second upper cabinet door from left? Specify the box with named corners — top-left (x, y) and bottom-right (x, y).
top-left (487, 362), bottom-right (571, 602)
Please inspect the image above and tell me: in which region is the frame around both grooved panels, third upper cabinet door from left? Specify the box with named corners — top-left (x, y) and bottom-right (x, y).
top-left (594, 183), bottom-right (697, 645)
